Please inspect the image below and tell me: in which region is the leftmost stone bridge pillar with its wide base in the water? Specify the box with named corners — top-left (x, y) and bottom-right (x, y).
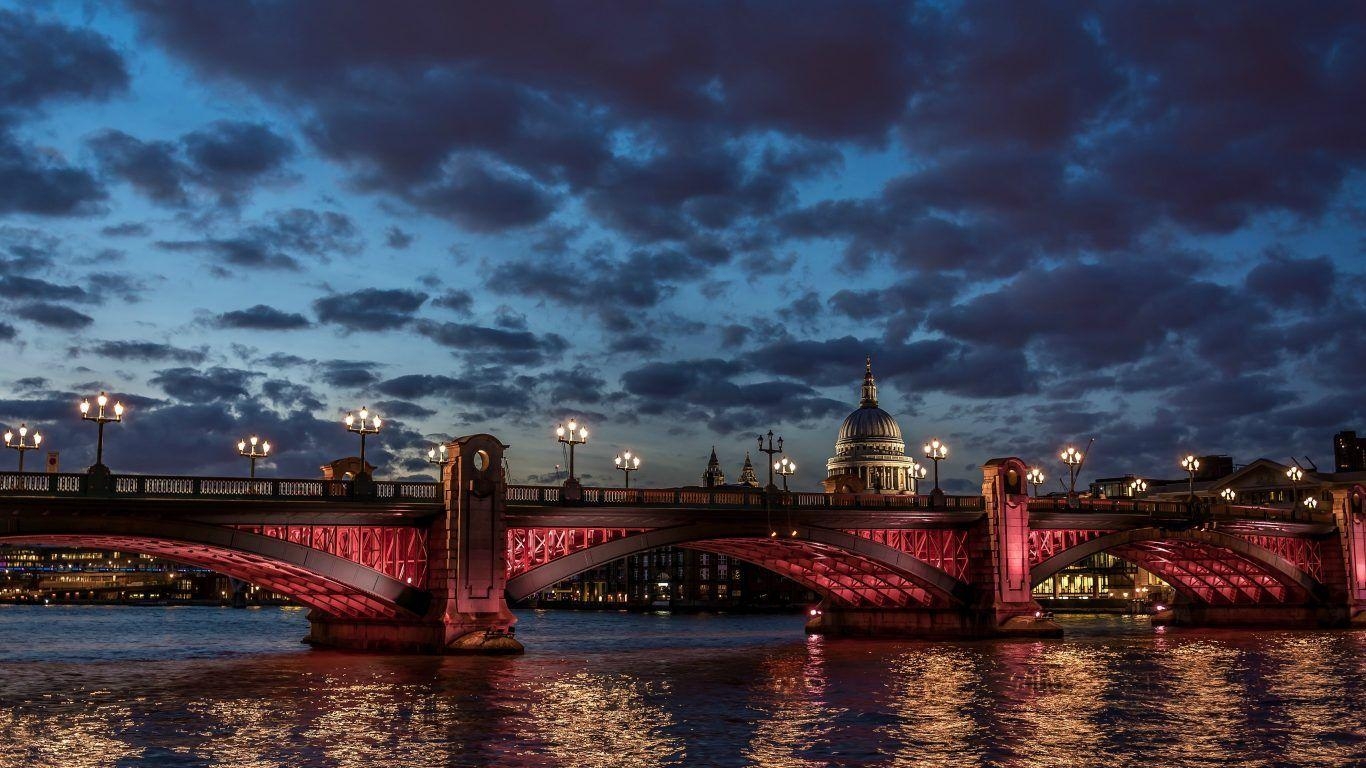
top-left (307, 435), bottom-right (523, 653)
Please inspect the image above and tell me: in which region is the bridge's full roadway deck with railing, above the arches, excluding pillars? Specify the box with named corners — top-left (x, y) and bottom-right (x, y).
top-left (0, 473), bottom-right (1335, 536)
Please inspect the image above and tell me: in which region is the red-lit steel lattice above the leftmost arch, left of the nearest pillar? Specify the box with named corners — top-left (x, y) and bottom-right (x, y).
top-left (236, 525), bottom-right (428, 588)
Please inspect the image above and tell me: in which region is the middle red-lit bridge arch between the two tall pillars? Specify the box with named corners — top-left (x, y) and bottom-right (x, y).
top-left (507, 523), bottom-right (974, 607)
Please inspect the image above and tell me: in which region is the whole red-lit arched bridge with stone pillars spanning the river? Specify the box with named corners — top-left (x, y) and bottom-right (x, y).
top-left (0, 435), bottom-right (1366, 653)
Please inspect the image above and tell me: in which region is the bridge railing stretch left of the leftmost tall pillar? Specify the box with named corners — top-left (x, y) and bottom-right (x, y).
top-left (0, 471), bottom-right (438, 502)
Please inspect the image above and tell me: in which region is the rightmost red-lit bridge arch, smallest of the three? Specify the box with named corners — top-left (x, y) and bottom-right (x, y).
top-left (1030, 527), bottom-right (1324, 605)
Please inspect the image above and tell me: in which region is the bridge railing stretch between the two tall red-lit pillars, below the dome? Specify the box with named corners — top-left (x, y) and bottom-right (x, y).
top-left (507, 485), bottom-right (986, 511)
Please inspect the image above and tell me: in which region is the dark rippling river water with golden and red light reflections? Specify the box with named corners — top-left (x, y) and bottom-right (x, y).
top-left (0, 605), bottom-right (1366, 768)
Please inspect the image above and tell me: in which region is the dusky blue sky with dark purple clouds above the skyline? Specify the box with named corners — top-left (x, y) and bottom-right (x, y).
top-left (0, 0), bottom-right (1366, 489)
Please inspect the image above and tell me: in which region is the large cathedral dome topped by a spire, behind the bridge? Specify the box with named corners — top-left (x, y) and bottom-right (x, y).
top-left (824, 358), bottom-right (917, 493)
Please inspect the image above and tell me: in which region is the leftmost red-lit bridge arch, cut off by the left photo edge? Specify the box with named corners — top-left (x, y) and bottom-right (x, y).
top-left (0, 515), bottom-right (430, 619)
